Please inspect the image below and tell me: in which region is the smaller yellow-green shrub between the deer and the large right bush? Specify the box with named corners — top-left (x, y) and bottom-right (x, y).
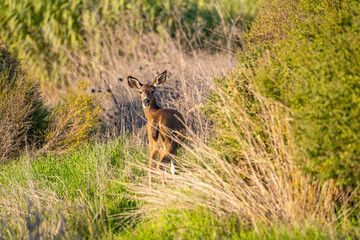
top-left (203, 71), bottom-right (271, 164)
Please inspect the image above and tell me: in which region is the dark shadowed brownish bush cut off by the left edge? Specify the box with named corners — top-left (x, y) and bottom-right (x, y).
top-left (0, 45), bottom-right (49, 161)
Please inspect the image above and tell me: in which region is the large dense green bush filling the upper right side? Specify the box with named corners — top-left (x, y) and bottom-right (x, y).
top-left (240, 0), bottom-right (360, 186)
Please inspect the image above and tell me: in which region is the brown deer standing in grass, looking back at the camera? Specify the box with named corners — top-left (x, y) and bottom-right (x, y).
top-left (127, 71), bottom-right (186, 188)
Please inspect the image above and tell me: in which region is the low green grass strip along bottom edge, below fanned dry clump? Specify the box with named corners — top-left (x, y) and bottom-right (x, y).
top-left (120, 208), bottom-right (359, 240)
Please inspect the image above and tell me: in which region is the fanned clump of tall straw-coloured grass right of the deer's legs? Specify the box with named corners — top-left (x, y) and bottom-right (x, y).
top-left (120, 69), bottom-right (348, 226)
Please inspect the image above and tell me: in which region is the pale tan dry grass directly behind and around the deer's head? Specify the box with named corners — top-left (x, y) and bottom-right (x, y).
top-left (57, 23), bottom-right (236, 139)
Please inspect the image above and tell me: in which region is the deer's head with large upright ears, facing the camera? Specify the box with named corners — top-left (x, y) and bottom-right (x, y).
top-left (128, 71), bottom-right (166, 109)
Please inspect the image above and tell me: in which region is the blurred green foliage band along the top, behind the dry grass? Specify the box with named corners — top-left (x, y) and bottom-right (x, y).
top-left (0, 0), bottom-right (257, 87)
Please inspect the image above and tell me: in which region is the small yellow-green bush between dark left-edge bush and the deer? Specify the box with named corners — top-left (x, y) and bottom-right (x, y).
top-left (40, 79), bottom-right (102, 152)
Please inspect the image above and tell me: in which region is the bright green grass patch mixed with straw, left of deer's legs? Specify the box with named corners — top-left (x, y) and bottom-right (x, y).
top-left (0, 139), bottom-right (145, 238)
